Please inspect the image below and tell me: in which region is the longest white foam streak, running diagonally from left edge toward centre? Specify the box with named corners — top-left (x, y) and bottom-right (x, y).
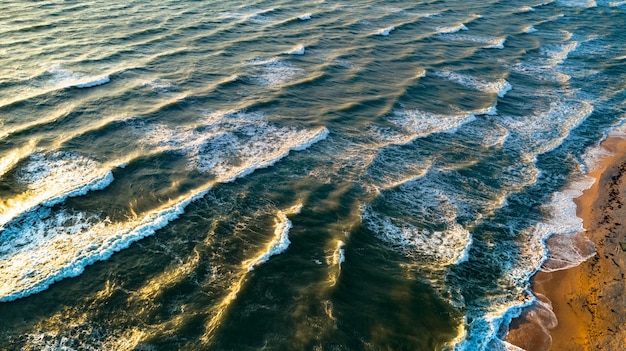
top-left (0, 115), bottom-right (328, 301)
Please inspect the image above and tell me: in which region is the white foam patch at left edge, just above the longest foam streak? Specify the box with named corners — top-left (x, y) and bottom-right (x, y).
top-left (0, 151), bottom-right (113, 229)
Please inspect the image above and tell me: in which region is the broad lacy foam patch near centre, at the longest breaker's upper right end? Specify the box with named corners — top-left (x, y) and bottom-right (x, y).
top-left (135, 111), bottom-right (329, 182)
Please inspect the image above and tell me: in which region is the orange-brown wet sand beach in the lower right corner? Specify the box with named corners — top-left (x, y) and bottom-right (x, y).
top-left (506, 135), bottom-right (626, 351)
